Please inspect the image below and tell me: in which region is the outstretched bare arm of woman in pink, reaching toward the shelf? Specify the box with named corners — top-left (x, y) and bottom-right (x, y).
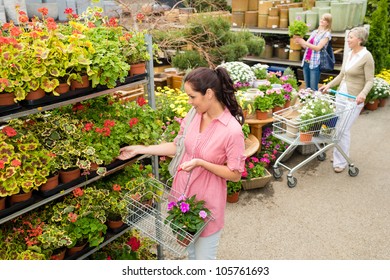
top-left (118, 142), bottom-right (176, 160)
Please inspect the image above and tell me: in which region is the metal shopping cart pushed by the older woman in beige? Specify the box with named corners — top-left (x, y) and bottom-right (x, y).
top-left (273, 90), bottom-right (359, 188)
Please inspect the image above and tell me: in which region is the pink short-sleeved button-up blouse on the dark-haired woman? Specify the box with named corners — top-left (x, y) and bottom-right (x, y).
top-left (173, 108), bottom-right (245, 236)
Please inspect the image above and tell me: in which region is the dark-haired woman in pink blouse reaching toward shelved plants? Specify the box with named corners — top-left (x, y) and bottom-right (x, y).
top-left (118, 67), bottom-right (245, 259)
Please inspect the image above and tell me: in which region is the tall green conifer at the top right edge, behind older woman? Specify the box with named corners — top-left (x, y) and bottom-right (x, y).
top-left (367, 0), bottom-right (390, 73)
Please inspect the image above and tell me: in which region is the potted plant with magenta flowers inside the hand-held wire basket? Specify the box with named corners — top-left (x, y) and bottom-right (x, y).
top-left (164, 195), bottom-right (211, 247)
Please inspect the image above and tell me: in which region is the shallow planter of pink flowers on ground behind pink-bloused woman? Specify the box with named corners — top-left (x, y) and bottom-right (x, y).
top-left (241, 156), bottom-right (272, 190)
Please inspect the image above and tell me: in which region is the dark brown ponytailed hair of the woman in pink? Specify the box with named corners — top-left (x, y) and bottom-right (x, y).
top-left (184, 67), bottom-right (244, 125)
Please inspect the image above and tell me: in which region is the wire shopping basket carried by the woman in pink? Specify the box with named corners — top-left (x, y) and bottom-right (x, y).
top-left (125, 178), bottom-right (213, 256)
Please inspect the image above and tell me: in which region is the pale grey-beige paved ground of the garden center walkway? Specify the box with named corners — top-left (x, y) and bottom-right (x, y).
top-left (218, 101), bottom-right (390, 260)
